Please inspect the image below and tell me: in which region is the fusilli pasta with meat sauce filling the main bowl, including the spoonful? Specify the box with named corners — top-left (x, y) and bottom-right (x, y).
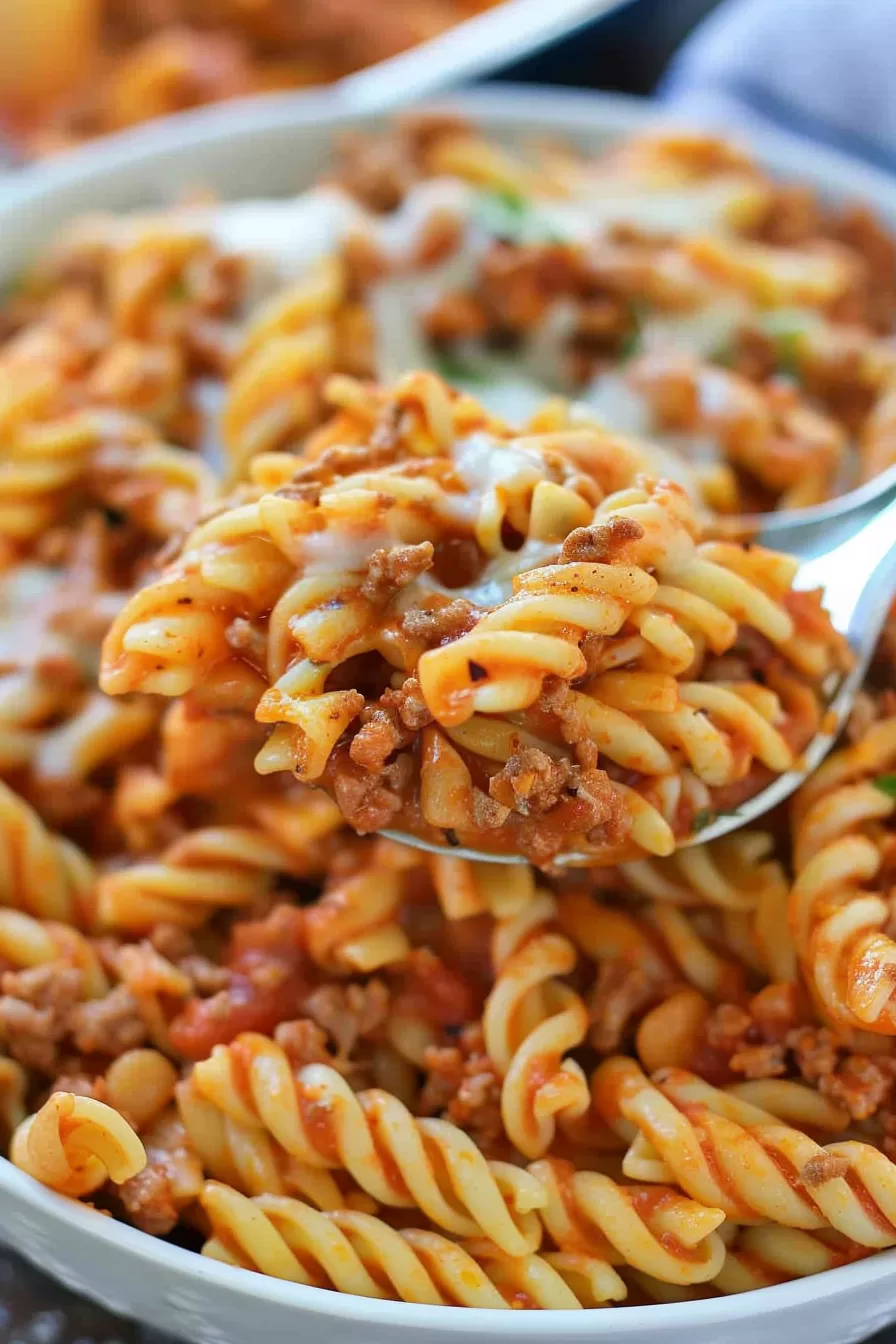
top-left (0, 116), bottom-right (896, 1309)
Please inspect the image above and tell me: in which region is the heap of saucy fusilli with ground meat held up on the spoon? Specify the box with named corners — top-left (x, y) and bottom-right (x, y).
top-left (102, 375), bottom-right (841, 864)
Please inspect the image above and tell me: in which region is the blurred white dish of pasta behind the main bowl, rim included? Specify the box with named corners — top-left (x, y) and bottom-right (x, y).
top-left (0, 0), bottom-right (671, 161)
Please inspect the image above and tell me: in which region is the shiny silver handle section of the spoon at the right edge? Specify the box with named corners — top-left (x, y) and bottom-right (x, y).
top-left (794, 500), bottom-right (896, 657)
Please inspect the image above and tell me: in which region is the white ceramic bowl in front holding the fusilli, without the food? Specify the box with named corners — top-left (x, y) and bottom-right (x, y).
top-left (0, 86), bottom-right (896, 1344)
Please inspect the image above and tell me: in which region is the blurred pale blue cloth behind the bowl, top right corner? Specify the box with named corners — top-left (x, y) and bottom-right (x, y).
top-left (660, 0), bottom-right (896, 173)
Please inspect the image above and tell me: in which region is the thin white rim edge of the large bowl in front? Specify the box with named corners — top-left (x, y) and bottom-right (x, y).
top-left (0, 83), bottom-right (896, 1341)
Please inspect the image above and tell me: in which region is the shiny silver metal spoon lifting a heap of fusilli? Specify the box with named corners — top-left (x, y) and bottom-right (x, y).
top-left (384, 495), bottom-right (896, 867)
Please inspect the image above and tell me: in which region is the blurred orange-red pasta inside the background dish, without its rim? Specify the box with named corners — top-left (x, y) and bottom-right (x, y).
top-left (0, 0), bottom-right (497, 159)
